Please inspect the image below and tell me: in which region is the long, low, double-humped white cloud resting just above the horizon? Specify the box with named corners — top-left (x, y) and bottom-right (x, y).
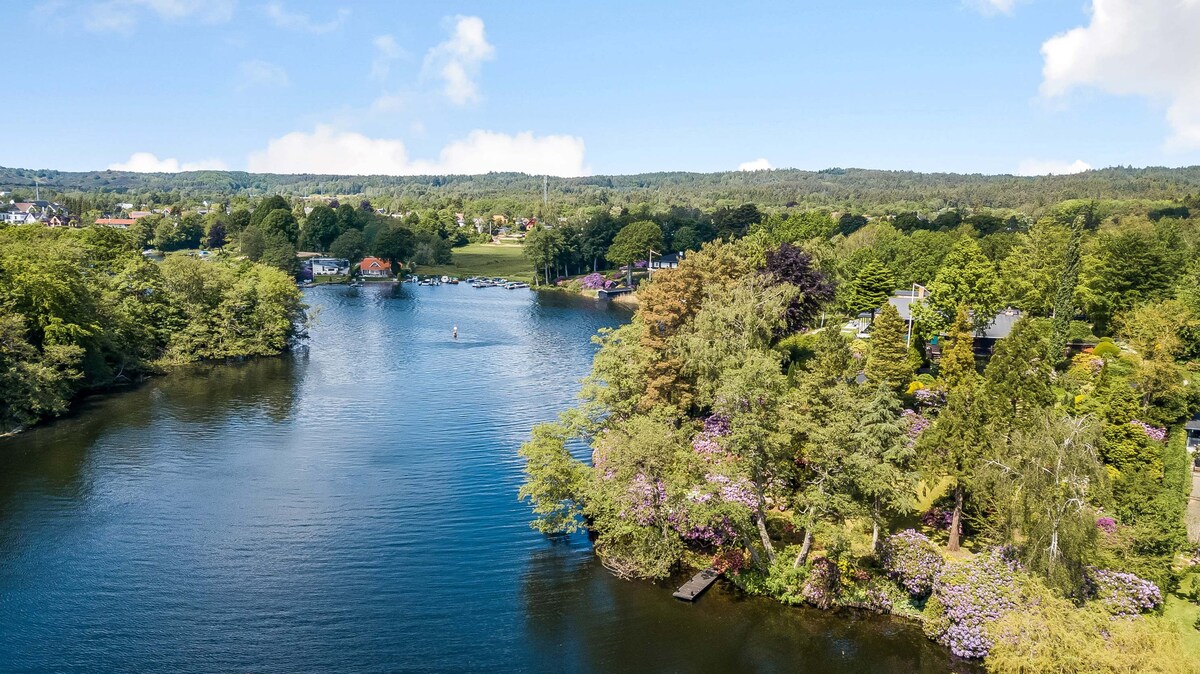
top-left (246, 125), bottom-right (588, 176)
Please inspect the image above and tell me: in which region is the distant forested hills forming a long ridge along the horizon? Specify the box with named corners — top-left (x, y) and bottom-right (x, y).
top-left (7, 167), bottom-right (1200, 215)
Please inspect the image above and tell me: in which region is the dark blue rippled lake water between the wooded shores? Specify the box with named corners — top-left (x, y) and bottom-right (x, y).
top-left (0, 285), bottom-right (952, 673)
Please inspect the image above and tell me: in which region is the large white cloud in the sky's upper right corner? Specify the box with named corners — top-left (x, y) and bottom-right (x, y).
top-left (1042, 0), bottom-right (1200, 150)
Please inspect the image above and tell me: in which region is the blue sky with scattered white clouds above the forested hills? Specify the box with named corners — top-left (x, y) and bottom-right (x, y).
top-left (7, 0), bottom-right (1200, 175)
